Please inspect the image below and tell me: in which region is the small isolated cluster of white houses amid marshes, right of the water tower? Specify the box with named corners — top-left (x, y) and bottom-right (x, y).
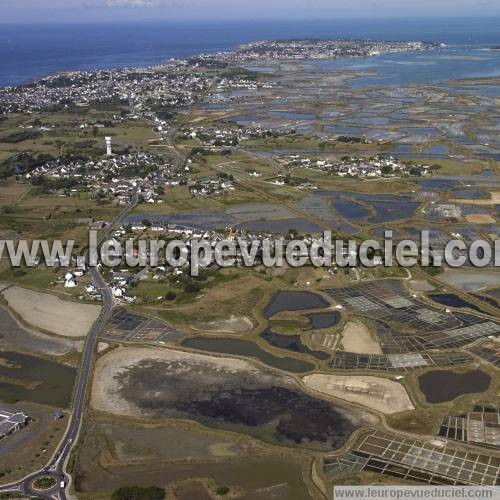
top-left (279, 154), bottom-right (430, 178)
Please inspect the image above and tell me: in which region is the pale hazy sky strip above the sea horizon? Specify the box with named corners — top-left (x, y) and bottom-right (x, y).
top-left (0, 0), bottom-right (500, 23)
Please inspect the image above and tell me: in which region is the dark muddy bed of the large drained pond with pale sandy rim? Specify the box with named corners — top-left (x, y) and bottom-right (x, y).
top-left (115, 357), bottom-right (368, 450)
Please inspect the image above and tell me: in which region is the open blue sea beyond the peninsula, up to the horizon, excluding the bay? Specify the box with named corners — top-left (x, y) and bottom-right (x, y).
top-left (0, 18), bottom-right (500, 87)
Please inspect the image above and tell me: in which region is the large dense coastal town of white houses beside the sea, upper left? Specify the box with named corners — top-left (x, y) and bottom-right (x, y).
top-left (0, 51), bottom-right (280, 116)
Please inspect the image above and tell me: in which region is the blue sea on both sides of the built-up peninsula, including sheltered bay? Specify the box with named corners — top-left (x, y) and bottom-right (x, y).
top-left (0, 18), bottom-right (500, 86)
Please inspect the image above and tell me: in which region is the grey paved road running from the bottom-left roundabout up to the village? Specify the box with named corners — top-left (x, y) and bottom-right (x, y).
top-left (0, 194), bottom-right (137, 500)
